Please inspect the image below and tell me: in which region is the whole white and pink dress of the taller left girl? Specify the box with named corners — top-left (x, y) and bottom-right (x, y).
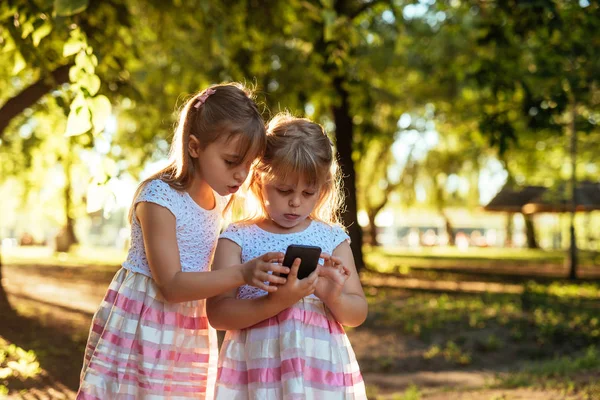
top-left (77, 180), bottom-right (227, 400)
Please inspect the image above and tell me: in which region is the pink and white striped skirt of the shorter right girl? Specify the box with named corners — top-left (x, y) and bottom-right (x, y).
top-left (215, 298), bottom-right (367, 400)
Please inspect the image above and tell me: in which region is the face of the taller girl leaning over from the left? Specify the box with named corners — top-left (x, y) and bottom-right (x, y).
top-left (195, 135), bottom-right (254, 196)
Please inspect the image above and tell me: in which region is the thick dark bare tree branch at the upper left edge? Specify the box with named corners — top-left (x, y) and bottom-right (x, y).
top-left (0, 64), bottom-right (73, 139)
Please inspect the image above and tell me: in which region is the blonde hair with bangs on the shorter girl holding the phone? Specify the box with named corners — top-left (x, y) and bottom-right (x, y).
top-left (243, 113), bottom-right (343, 225)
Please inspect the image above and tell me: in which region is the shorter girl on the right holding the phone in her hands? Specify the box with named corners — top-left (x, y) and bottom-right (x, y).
top-left (207, 114), bottom-right (367, 399)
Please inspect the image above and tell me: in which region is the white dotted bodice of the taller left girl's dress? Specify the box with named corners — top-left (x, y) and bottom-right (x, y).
top-left (123, 179), bottom-right (228, 277)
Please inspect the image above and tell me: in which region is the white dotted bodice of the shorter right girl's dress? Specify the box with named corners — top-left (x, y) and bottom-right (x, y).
top-left (220, 221), bottom-right (350, 299)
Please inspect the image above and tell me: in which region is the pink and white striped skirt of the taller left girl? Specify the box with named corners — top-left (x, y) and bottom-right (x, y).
top-left (77, 268), bottom-right (217, 400)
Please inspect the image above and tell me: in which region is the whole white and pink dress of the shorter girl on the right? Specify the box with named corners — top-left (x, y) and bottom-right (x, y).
top-left (215, 221), bottom-right (367, 400)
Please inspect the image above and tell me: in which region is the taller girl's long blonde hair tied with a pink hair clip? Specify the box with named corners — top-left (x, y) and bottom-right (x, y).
top-left (129, 83), bottom-right (266, 222)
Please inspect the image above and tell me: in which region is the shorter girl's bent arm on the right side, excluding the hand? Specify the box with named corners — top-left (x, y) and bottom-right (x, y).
top-left (321, 241), bottom-right (368, 327)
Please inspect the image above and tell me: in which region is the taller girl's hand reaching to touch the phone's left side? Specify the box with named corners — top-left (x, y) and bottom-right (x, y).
top-left (242, 252), bottom-right (290, 292)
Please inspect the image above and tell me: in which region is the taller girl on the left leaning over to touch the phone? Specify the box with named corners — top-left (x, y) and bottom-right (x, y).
top-left (77, 84), bottom-right (288, 400)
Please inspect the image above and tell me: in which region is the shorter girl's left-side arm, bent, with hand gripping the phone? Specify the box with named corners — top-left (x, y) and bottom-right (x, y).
top-left (206, 239), bottom-right (318, 330)
